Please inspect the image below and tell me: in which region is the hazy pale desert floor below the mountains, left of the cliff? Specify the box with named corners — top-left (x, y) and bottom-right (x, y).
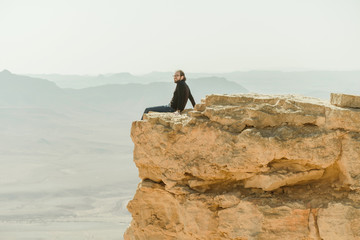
top-left (0, 108), bottom-right (140, 240)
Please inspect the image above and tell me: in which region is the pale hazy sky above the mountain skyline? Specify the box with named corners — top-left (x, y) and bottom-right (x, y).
top-left (0, 0), bottom-right (360, 74)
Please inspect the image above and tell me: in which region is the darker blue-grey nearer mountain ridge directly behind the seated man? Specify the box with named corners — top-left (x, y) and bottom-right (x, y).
top-left (0, 71), bottom-right (248, 112)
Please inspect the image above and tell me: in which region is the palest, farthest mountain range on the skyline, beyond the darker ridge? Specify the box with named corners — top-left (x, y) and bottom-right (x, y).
top-left (28, 71), bottom-right (360, 99)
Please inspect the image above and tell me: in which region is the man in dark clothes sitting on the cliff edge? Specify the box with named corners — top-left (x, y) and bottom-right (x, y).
top-left (141, 70), bottom-right (195, 120)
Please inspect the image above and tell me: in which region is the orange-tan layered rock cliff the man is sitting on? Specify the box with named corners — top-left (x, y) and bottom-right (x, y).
top-left (124, 94), bottom-right (360, 240)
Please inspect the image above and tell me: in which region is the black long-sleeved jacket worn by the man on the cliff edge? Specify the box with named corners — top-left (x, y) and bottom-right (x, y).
top-left (170, 80), bottom-right (195, 111)
